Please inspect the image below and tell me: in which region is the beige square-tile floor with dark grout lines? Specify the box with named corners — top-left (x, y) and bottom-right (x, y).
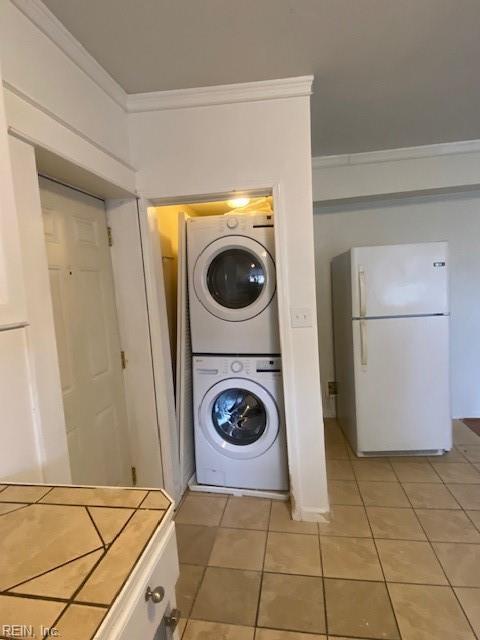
top-left (176, 420), bottom-right (480, 640)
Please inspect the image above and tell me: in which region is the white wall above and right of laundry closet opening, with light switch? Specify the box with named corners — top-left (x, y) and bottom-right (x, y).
top-left (130, 95), bottom-right (328, 519)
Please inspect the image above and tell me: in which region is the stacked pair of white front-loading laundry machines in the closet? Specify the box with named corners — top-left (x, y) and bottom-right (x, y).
top-left (187, 213), bottom-right (288, 491)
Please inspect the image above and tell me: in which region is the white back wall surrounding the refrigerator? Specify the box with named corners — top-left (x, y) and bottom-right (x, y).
top-left (314, 192), bottom-right (480, 417)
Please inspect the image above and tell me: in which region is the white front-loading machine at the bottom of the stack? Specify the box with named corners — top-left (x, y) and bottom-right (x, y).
top-left (193, 356), bottom-right (288, 491)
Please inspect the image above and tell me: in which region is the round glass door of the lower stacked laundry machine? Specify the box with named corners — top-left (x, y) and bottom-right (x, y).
top-left (198, 378), bottom-right (279, 458)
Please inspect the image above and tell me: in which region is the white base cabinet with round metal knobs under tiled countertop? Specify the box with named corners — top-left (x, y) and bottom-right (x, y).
top-left (95, 522), bottom-right (179, 640)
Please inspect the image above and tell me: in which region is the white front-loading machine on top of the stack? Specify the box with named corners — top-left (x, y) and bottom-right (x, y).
top-left (187, 213), bottom-right (280, 354)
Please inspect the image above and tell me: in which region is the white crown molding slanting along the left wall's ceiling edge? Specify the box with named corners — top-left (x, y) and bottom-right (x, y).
top-left (11, 0), bottom-right (127, 110)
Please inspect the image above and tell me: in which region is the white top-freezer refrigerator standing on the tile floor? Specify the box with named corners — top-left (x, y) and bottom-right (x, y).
top-left (332, 242), bottom-right (452, 456)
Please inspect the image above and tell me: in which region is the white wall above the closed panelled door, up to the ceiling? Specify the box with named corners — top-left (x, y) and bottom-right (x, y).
top-left (0, 0), bottom-right (135, 191)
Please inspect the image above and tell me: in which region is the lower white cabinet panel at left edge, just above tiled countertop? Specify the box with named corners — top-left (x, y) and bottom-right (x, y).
top-left (0, 328), bottom-right (42, 482)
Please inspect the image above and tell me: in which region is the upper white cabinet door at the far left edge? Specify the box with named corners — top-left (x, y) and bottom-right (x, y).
top-left (0, 70), bottom-right (27, 329)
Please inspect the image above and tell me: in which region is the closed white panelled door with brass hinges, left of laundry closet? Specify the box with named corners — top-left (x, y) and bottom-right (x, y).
top-left (40, 178), bottom-right (131, 485)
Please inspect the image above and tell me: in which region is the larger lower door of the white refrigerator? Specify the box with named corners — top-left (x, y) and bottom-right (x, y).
top-left (353, 316), bottom-right (452, 454)
